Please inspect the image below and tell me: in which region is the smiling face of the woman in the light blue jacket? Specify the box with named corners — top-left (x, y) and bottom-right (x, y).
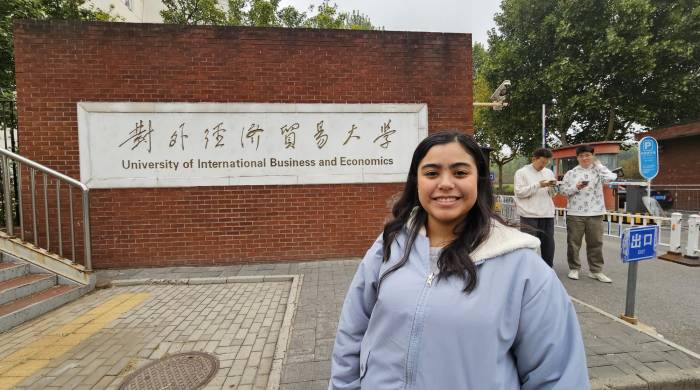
top-left (418, 141), bottom-right (479, 235)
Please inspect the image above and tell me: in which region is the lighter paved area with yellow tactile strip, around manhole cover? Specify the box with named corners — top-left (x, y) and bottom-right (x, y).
top-left (0, 278), bottom-right (293, 390)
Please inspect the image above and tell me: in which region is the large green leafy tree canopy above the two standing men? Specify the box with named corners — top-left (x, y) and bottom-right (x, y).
top-left (482, 0), bottom-right (700, 149)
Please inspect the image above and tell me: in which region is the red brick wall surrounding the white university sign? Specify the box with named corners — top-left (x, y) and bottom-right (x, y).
top-left (14, 21), bottom-right (472, 268)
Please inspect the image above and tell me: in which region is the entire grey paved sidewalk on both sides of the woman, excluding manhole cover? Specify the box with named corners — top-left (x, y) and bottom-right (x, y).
top-left (0, 259), bottom-right (700, 390)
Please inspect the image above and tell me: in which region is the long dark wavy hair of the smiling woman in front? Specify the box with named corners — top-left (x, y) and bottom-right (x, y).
top-left (377, 130), bottom-right (502, 293)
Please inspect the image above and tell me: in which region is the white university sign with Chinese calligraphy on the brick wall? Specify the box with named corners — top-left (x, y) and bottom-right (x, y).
top-left (78, 102), bottom-right (428, 188)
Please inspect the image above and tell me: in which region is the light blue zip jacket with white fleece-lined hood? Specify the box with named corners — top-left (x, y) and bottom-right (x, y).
top-left (328, 223), bottom-right (589, 390)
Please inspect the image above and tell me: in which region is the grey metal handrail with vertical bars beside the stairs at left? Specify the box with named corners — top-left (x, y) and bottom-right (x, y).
top-left (0, 148), bottom-right (92, 270)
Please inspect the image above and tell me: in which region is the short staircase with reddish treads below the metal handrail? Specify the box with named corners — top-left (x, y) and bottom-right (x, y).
top-left (0, 252), bottom-right (86, 333)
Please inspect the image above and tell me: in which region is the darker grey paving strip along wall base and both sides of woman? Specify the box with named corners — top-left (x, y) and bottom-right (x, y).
top-left (98, 259), bottom-right (700, 390)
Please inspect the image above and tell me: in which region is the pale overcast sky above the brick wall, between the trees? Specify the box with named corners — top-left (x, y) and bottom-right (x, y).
top-left (280, 0), bottom-right (501, 44)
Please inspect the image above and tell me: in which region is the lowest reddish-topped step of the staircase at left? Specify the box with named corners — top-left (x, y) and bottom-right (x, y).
top-left (0, 285), bottom-right (80, 332)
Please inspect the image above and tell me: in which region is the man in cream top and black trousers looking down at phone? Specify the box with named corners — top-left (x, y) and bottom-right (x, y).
top-left (514, 148), bottom-right (556, 267)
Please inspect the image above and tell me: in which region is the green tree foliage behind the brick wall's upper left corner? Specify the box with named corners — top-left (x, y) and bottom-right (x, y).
top-left (0, 0), bottom-right (116, 98)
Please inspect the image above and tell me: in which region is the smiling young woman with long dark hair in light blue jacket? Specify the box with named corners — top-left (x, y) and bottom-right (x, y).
top-left (328, 131), bottom-right (589, 390)
